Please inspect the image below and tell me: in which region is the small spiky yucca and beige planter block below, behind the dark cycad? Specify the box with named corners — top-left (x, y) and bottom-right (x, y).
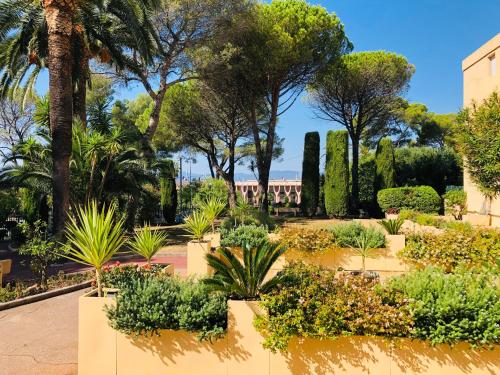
top-left (185, 211), bottom-right (211, 276)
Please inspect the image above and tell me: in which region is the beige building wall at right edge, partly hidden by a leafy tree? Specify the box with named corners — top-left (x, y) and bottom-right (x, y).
top-left (462, 34), bottom-right (500, 227)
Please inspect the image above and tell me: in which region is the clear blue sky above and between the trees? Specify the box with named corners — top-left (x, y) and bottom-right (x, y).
top-left (33, 0), bottom-right (500, 173)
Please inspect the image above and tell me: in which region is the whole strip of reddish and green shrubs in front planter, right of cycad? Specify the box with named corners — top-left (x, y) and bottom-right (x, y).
top-left (254, 263), bottom-right (500, 351)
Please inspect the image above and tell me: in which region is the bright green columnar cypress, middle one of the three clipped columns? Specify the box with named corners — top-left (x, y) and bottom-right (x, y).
top-left (324, 130), bottom-right (349, 216)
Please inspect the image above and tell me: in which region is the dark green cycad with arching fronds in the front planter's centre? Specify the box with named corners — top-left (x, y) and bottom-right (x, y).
top-left (204, 243), bottom-right (285, 299)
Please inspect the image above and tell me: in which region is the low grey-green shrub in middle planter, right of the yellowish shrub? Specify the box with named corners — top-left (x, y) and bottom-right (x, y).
top-left (331, 221), bottom-right (385, 249)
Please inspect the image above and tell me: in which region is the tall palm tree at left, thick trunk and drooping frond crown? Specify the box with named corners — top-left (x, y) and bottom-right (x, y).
top-left (0, 0), bottom-right (156, 233)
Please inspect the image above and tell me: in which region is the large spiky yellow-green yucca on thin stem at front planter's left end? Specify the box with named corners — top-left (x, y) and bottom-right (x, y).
top-left (61, 201), bottom-right (126, 297)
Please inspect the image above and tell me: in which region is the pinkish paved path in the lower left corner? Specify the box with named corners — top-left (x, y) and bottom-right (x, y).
top-left (0, 290), bottom-right (85, 375)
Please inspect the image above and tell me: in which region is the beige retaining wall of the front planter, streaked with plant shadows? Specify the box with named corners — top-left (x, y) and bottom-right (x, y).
top-left (78, 297), bottom-right (500, 375)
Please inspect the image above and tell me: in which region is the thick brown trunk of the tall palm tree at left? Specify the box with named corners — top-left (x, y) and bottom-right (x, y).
top-left (44, 0), bottom-right (76, 234)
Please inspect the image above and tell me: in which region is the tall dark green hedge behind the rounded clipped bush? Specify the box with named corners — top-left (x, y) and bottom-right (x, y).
top-left (395, 147), bottom-right (463, 195)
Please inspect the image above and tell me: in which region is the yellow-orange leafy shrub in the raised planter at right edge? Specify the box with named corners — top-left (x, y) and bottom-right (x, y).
top-left (401, 226), bottom-right (500, 271)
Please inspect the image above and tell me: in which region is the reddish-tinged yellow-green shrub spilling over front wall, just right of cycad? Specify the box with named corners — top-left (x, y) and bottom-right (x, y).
top-left (255, 263), bottom-right (413, 351)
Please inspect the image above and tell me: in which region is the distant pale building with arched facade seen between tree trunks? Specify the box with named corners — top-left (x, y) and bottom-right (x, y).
top-left (236, 180), bottom-right (302, 204)
